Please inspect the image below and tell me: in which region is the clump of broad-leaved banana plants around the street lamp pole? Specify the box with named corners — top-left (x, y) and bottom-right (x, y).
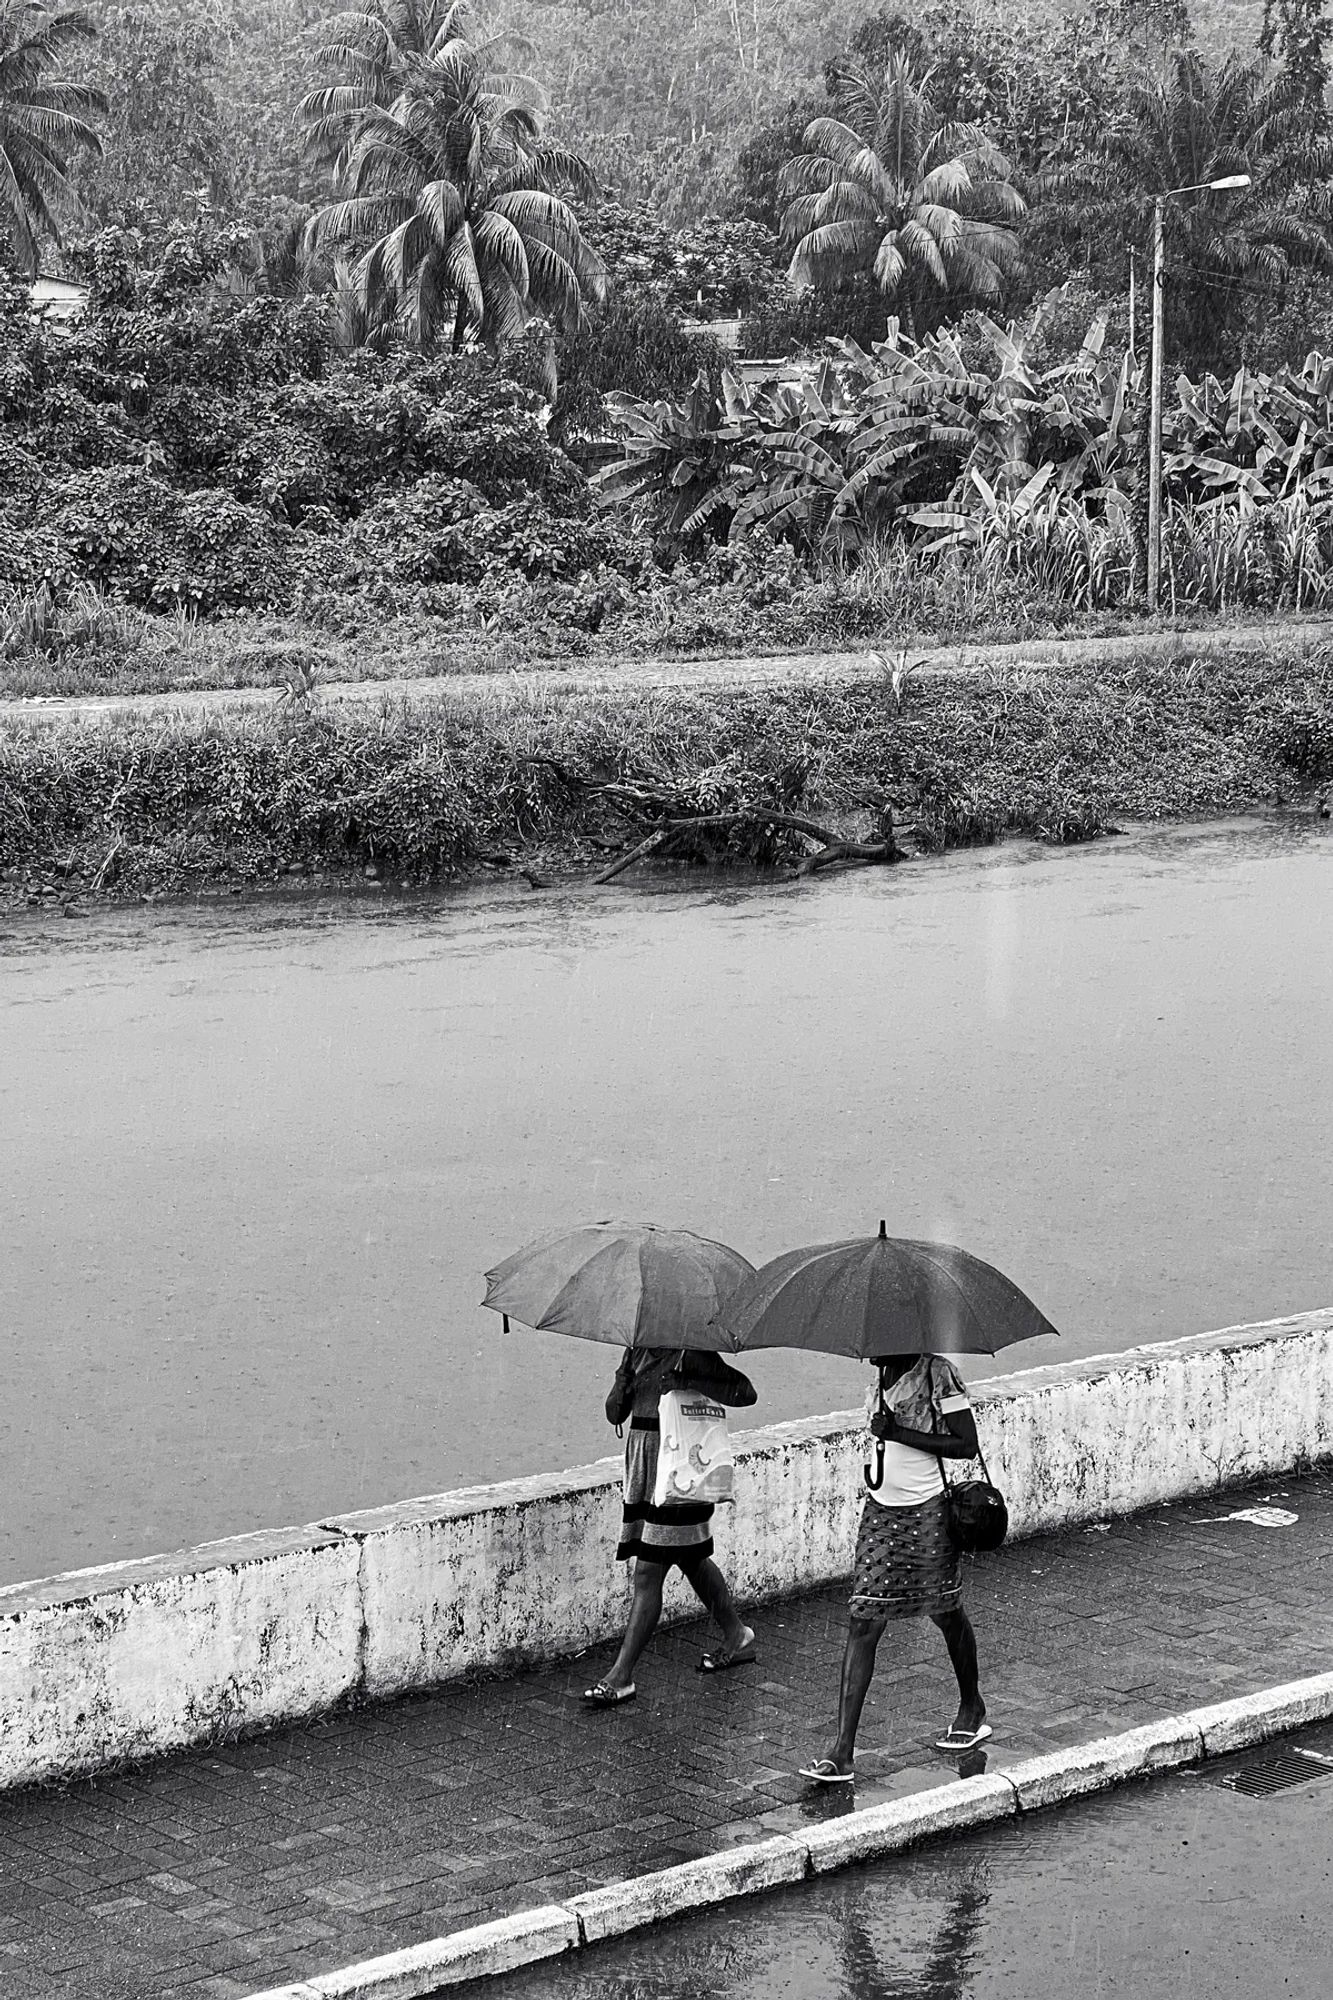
top-left (598, 278), bottom-right (1333, 584)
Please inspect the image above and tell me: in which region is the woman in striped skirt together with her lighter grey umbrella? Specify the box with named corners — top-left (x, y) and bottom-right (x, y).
top-left (482, 1222), bottom-right (757, 1708)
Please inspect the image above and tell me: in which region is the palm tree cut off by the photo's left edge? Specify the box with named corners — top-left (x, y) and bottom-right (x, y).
top-left (0, 0), bottom-right (106, 272)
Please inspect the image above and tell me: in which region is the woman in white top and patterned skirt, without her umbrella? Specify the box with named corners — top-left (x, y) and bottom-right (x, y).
top-left (801, 1354), bottom-right (991, 1784)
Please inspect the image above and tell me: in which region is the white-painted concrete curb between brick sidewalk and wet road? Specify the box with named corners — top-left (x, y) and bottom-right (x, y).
top-left (248, 1674), bottom-right (1333, 2000)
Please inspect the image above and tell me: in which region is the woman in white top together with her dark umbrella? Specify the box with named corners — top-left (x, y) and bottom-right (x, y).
top-left (721, 1222), bottom-right (1055, 1784)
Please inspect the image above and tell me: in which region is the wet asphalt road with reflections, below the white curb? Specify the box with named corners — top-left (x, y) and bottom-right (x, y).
top-left (482, 1726), bottom-right (1333, 2000)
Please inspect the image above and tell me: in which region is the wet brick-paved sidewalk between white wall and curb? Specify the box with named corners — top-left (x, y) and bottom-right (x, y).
top-left (0, 1470), bottom-right (1333, 2000)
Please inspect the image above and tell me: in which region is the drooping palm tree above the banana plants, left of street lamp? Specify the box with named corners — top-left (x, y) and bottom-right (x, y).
top-left (781, 54), bottom-right (1025, 334)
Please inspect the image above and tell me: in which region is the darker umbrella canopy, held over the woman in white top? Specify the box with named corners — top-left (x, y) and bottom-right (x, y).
top-left (721, 1222), bottom-right (1055, 1360)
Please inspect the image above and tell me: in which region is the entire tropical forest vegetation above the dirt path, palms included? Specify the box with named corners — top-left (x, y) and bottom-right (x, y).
top-left (0, 0), bottom-right (1333, 658)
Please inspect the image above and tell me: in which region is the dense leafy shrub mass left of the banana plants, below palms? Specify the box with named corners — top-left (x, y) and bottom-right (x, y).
top-left (0, 226), bottom-right (624, 618)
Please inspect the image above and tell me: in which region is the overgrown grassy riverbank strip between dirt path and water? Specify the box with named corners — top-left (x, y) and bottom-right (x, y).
top-left (0, 646), bottom-right (1333, 904)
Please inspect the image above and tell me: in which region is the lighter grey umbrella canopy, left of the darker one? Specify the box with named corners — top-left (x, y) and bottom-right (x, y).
top-left (482, 1222), bottom-right (755, 1352)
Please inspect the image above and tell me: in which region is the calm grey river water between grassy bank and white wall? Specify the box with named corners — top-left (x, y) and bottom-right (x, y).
top-left (0, 822), bottom-right (1333, 1582)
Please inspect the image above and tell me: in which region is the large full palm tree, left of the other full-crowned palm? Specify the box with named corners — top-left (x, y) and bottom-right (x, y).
top-left (304, 0), bottom-right (606, 350)
